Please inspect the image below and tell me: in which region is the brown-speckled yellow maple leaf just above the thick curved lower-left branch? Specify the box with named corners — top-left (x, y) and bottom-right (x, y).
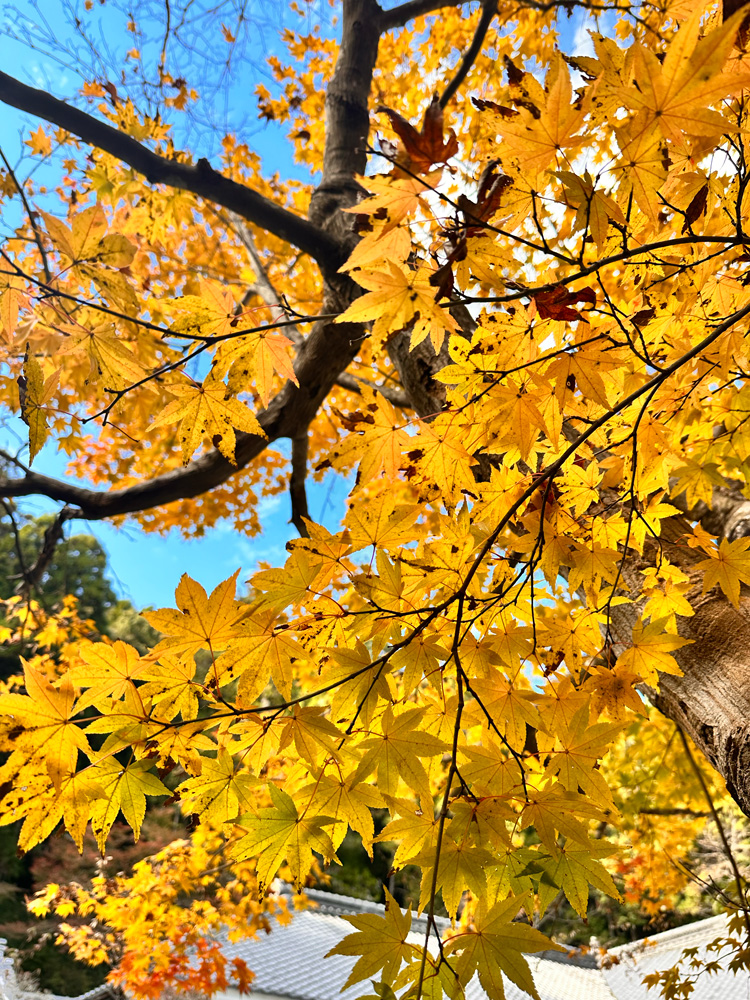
top-left (149, 374), bottom-right (266, 465)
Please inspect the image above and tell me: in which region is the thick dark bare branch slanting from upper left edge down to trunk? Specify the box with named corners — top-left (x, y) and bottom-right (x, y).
top-left (0, 72), bottom-right (347, 270)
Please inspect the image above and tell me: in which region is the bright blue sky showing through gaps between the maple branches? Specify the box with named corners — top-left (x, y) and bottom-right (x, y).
top-left (0, 0), bottom-right (348, 608)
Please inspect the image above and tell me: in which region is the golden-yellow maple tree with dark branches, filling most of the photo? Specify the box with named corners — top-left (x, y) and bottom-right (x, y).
top-left (0, 0), bottom-right (750, 1000)
